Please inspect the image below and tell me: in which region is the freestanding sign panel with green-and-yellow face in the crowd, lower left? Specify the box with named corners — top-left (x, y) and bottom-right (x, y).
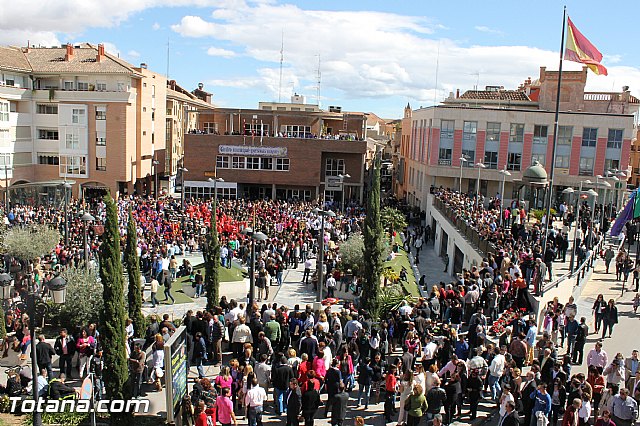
top-left (164, 326), bottom-right (187, 423)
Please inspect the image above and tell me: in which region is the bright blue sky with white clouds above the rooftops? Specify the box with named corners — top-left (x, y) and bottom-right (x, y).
top-left (0, 0), bottom-right (640, 118)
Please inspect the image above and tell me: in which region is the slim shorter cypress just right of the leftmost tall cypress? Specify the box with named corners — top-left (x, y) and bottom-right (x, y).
top-left (124, 209), bottom-right (145, 337)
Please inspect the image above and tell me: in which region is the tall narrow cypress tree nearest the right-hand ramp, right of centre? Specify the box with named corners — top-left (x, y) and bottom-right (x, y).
top-left (361, 153), bottom-right (384, 318)
